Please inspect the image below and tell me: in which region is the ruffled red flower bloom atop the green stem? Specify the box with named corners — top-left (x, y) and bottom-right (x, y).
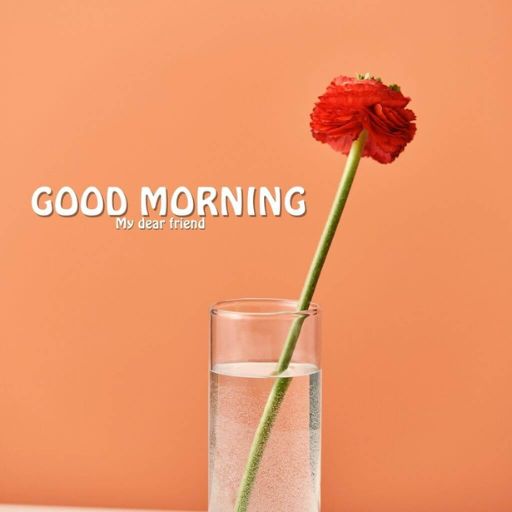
top-left (311, 75), bottom-right (416, 164)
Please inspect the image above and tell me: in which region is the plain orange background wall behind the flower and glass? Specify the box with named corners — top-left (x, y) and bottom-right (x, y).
top-left (0, 0), bottom-right (512, 512)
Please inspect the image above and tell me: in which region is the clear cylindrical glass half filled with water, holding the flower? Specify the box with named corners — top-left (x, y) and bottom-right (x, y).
top-left (208, 299), bottom-right (321, 512)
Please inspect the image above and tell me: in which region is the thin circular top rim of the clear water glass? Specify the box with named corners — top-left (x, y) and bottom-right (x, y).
top-left (210, 297), bottom-right (320, 318)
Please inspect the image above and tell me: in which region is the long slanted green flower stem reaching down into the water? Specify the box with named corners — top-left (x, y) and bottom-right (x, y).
top-left (234, 130), bottom-right (367, 512)
